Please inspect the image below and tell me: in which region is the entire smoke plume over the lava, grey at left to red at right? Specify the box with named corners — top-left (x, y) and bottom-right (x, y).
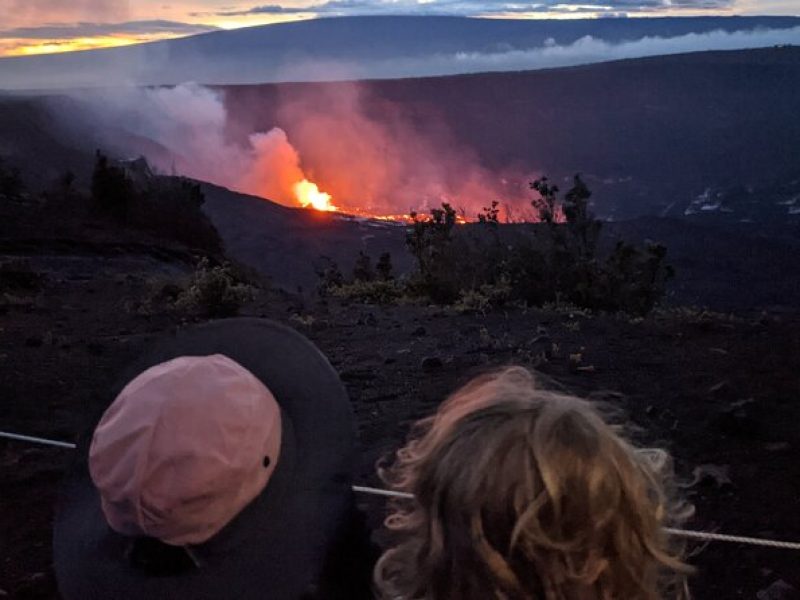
top-left (72, 84), bottom-right (525, 218)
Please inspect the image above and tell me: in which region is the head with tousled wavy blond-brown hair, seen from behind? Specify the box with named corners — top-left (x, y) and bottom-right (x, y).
top-left (376, 368), bottom-right (688, 600)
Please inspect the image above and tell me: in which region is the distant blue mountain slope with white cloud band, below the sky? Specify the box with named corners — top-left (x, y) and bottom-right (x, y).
top-left (0, 16), bottom-right (800, 89)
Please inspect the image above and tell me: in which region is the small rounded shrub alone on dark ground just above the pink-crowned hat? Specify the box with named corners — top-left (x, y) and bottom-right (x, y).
top-left (176, 258), bottom-right (255, 317)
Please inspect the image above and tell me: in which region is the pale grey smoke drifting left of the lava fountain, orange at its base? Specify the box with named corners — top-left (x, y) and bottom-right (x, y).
top-left (74, 84), bottom-right (304, 204)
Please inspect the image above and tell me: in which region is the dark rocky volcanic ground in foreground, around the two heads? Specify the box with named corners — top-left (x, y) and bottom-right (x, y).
top-left (0, 196), bottom-right (800, 600)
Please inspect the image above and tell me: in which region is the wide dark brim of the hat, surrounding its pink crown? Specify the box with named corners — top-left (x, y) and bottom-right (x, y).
top-left (53, 318), bottom-right (355, 600)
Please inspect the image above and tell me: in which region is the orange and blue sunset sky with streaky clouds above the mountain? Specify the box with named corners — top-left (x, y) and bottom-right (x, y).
top-left (0, 0), bottom-right (800, 56)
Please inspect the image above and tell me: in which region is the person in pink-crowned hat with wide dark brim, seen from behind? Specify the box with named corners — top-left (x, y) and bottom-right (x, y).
top-left (53, 319), bottom-right (374, 600)
